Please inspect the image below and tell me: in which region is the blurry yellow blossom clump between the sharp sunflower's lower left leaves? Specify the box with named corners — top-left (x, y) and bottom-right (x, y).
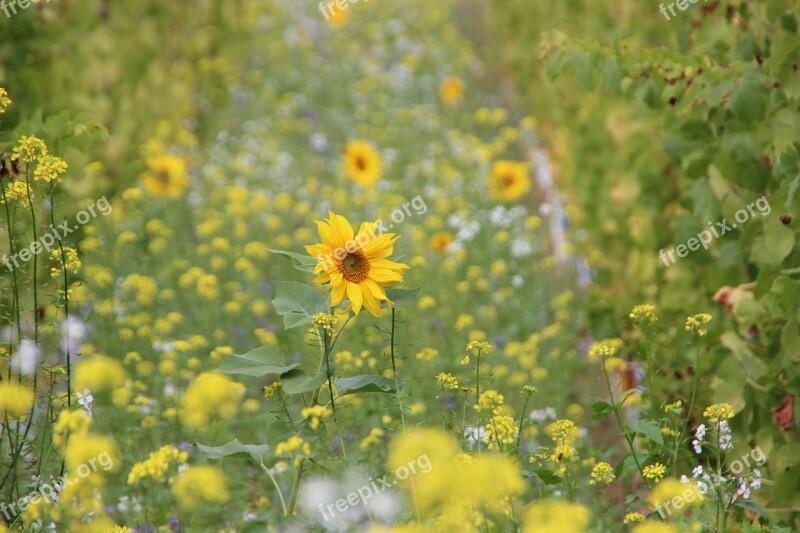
top-left (178, 372), bottom-right (245, 430)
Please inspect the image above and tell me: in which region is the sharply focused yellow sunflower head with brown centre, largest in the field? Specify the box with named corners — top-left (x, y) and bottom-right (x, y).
top-left (306, 212), bottom-right (408, 317)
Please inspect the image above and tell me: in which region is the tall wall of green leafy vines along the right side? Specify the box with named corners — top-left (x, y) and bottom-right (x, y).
top-left (492, 0), bottom-right (800, 518)
